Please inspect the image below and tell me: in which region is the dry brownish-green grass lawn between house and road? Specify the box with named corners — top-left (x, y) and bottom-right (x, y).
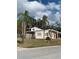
top-left (17, 38), bottom-right (61, 48)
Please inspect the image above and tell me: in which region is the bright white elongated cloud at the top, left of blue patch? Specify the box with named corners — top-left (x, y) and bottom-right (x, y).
top-left (24, 1), bottom-right (46, 12)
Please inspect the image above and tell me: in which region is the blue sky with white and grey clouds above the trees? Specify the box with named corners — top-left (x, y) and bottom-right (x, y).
top-left (17, 0), bottom-right (61, 24)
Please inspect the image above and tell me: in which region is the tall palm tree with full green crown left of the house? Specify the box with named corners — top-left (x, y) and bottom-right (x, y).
top-left (17, 11), bottom-right (36, 42)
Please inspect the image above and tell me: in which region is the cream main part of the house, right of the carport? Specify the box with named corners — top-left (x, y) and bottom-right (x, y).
top-left (35, 29), bottom-right (61, 39)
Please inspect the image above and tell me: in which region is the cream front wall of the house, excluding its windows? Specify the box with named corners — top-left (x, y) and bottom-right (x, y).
top-left (35, 30), bottom-right (56, 39)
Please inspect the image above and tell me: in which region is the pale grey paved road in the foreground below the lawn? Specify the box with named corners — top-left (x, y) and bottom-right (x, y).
top-left (17, 46), bottom-right (61, 59)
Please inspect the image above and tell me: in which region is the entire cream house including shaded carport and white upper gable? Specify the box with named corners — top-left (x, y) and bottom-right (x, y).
top-left (26, 27), bottom-right (61, 39)
